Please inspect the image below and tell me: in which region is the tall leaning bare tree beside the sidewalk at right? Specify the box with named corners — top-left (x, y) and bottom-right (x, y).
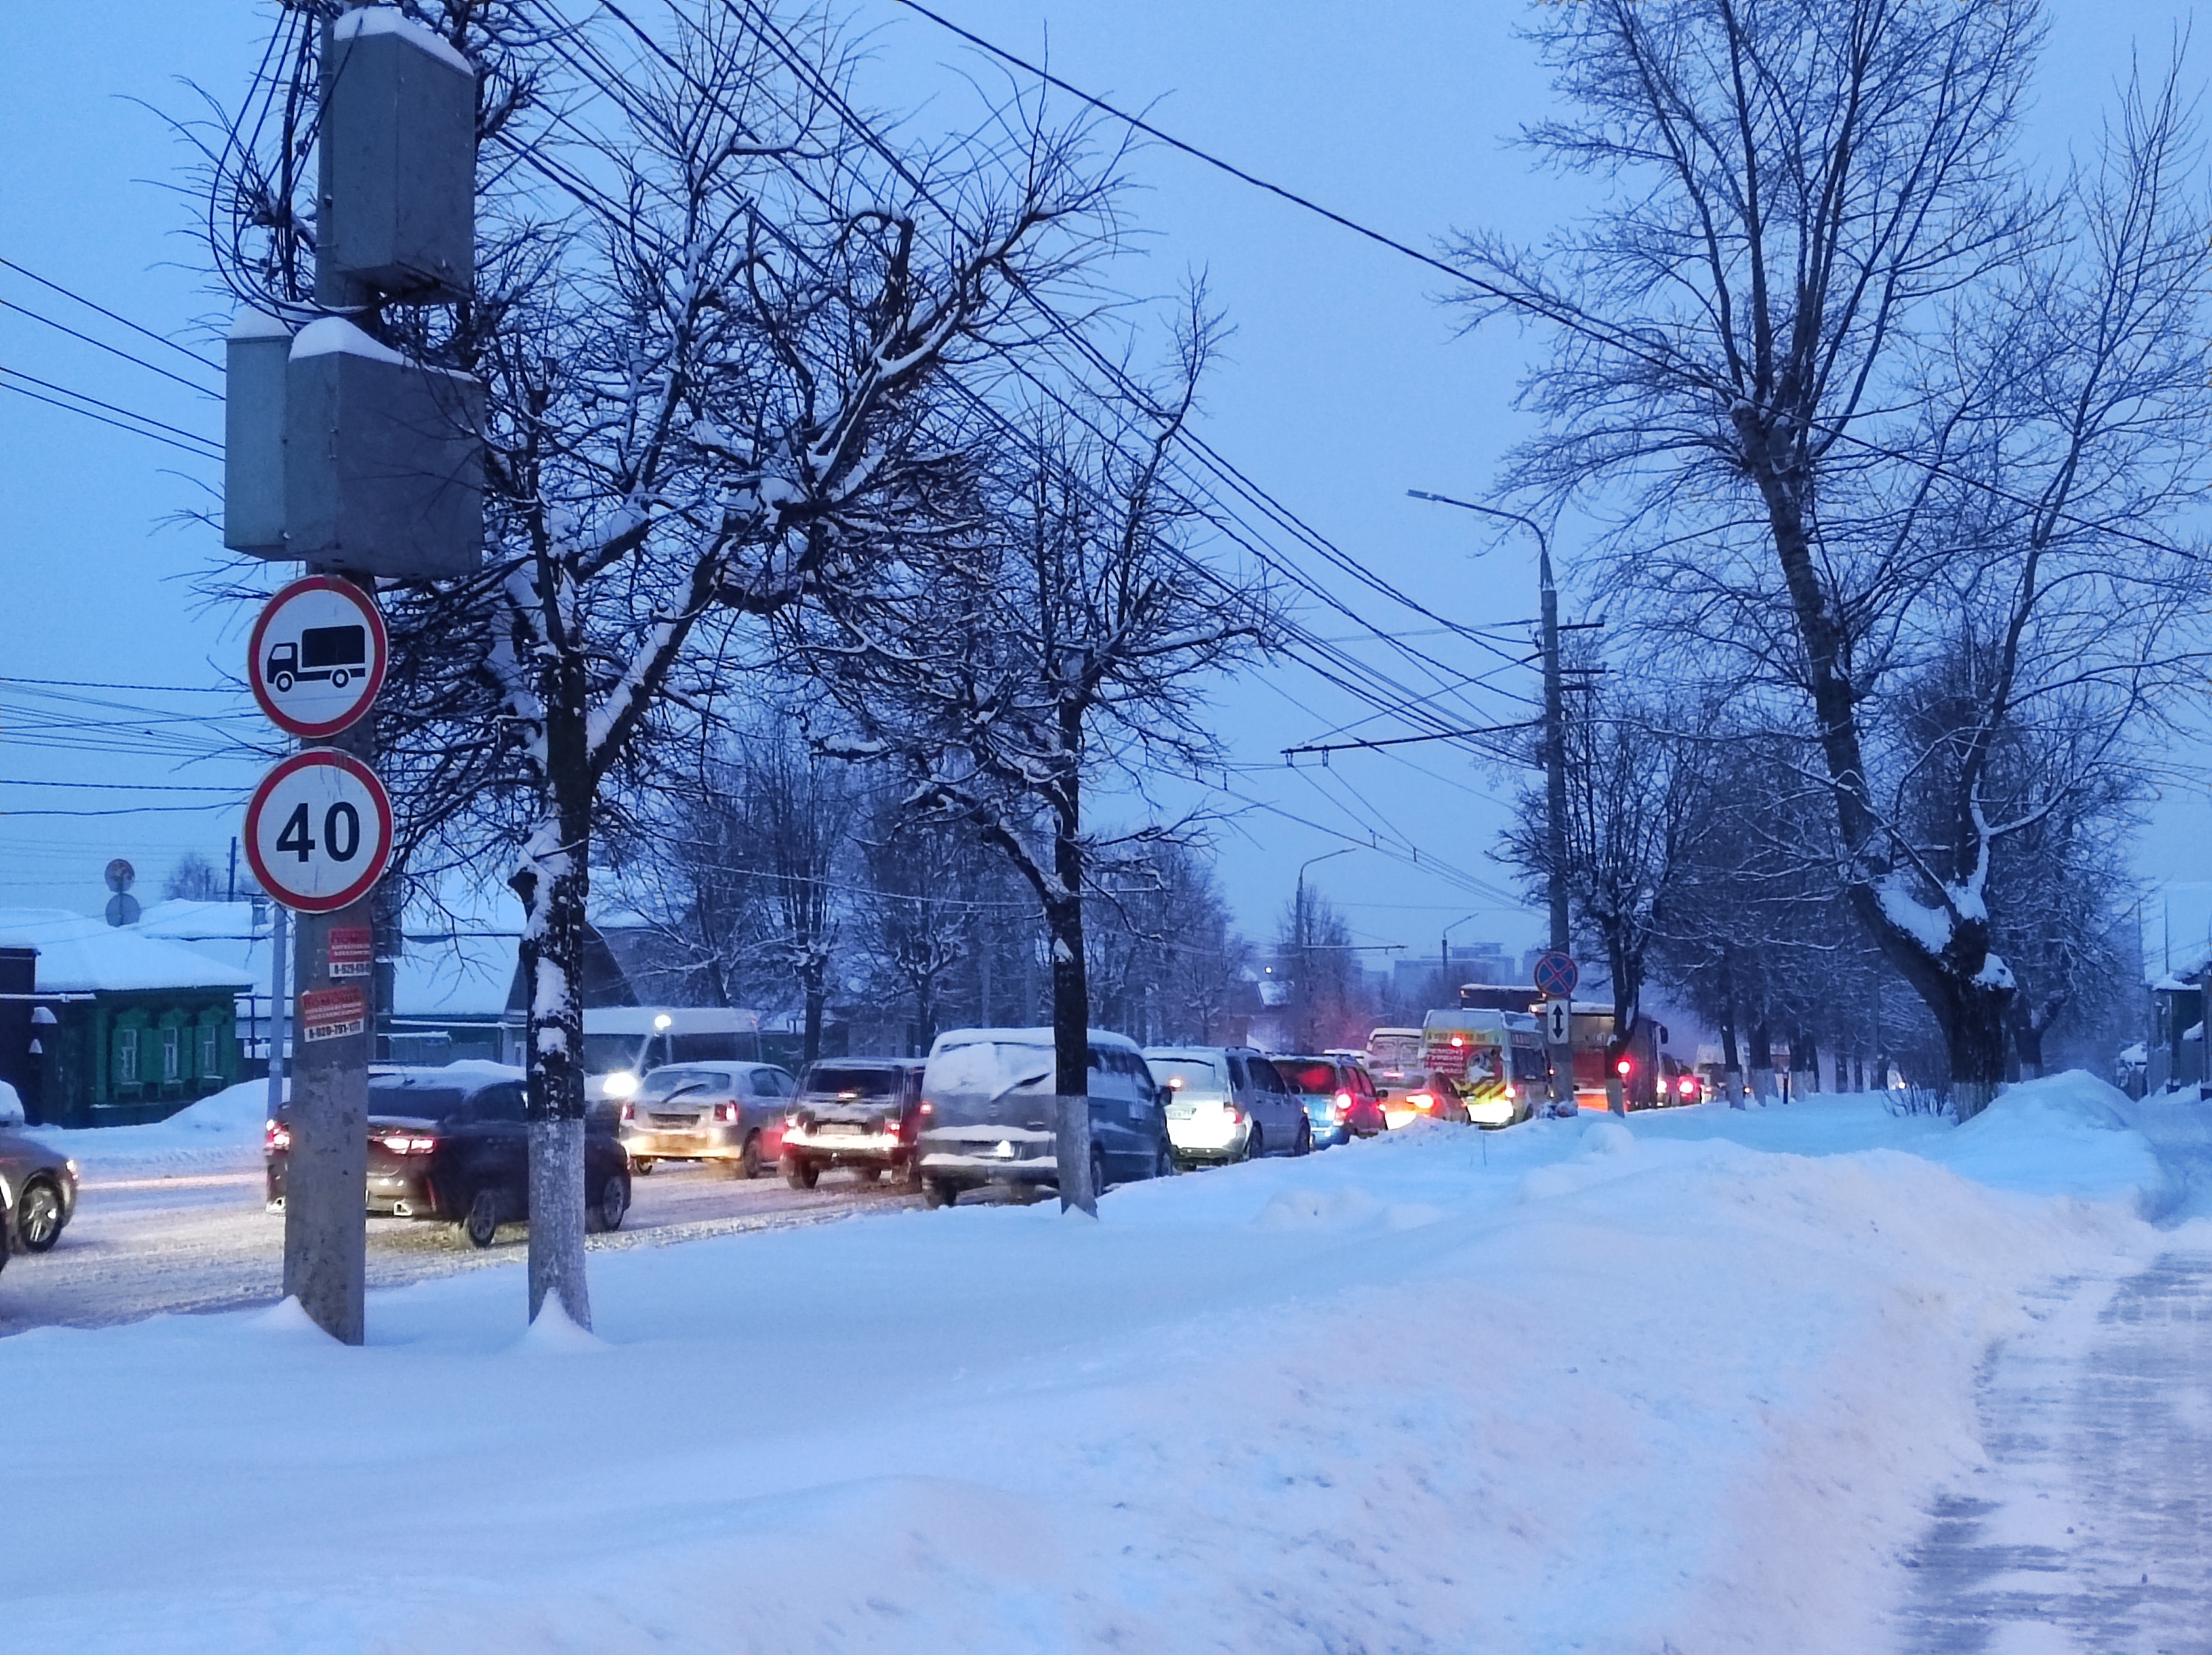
top-left (1458, 0), bottom-right (2212, 1115)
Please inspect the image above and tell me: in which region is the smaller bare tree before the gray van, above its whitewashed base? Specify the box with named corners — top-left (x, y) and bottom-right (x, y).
top-left (812, 318), bottom-right (1270, 1097)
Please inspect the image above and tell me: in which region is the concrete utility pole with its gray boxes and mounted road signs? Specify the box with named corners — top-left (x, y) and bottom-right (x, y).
top-left (224, 4), bottom-right (482, 1345)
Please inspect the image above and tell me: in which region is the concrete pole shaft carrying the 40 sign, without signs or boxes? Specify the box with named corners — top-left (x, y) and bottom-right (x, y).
top-left (283, 571), bottom-right (376, 1345)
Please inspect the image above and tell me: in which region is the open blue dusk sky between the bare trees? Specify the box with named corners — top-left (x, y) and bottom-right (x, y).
top-left (0, 0), bottom-right (2212, 978)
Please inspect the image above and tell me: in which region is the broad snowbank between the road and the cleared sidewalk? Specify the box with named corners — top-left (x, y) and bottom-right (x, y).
top-left (0, 1066), bottom-right (2154, 1655)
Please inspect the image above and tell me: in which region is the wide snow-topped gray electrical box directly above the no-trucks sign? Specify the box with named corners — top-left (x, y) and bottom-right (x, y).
top-left (283, 317), bottom-right (484, 580)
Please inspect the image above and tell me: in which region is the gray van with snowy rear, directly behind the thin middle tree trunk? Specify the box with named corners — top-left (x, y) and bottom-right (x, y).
top-left (916, 1029), bottom-right (1177, 1206)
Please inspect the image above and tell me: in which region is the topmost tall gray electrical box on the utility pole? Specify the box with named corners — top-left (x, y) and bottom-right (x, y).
top-left (314, 7), bottom-right (476, 306)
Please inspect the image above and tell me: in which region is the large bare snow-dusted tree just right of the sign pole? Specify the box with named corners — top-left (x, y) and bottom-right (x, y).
top-left (215, 0), bottom-right (1113, 1323)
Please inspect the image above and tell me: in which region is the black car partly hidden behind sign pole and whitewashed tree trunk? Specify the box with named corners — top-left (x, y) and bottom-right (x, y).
top-left (263, 1064), bottom-right (630, 1248)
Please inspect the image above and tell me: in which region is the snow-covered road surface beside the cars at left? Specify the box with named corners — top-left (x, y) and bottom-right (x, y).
top-left (0, 1155), bottom-right (920, 1334)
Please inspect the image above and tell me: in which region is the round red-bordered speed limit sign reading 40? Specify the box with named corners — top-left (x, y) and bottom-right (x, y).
top-left (246, 748), bottom-right (391, 914)
